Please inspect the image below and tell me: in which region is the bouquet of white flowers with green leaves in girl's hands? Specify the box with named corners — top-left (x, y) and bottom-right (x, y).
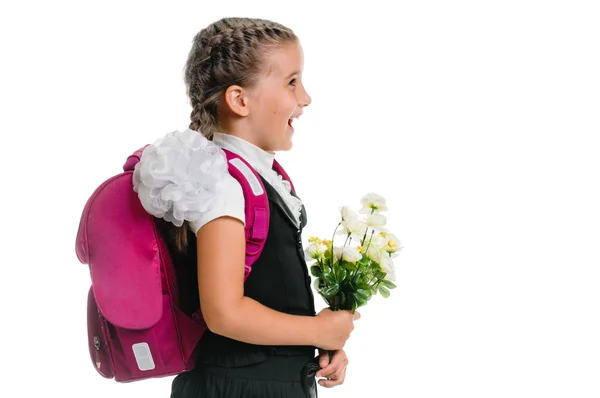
top-left (305, 193), bottom-right (403, 312)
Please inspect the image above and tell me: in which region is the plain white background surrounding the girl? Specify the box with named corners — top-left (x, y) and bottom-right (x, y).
top-left (0, 0), bottom-right (600, 398)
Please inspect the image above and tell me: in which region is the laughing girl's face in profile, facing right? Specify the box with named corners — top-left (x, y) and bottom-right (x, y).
top-left (248, 43), bottom-right (311, 152)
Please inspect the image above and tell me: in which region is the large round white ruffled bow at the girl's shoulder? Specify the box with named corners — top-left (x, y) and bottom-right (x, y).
top-left (133, 129), bottom-right (229, 226)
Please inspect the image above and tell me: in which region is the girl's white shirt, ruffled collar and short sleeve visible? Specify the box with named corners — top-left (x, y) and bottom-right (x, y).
top-left (190, 133), bottom-right (302, 233)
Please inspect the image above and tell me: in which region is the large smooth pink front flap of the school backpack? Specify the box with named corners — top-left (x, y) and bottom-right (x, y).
top-left (76, 171), bottom-right (163, 330)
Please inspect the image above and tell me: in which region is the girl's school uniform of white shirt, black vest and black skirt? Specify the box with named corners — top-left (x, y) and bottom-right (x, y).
top-left (171, 133), bottom-right (319, 398)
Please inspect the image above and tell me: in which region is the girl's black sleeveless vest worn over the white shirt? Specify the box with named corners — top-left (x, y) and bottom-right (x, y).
top-left (168, 177), bottom-right (315, 366)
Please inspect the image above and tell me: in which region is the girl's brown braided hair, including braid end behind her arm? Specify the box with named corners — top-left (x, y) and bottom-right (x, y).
top-left (164, 18), bottom-right (298, 251)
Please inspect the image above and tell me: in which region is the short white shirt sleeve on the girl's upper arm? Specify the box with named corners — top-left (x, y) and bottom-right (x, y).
top-left (190, 174), bottom-right (246, 234)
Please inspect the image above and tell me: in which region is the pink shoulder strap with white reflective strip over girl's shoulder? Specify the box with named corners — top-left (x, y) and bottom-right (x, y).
top-left (223, 149), bottom-right (269, 281)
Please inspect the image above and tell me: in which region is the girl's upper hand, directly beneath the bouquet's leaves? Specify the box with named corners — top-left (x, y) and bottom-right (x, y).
top-left (316, 308), bottom-right (360, 350)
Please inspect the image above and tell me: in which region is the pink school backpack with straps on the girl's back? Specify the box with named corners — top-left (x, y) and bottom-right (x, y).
top-left (76, 147), bottom-right (293, 382)
